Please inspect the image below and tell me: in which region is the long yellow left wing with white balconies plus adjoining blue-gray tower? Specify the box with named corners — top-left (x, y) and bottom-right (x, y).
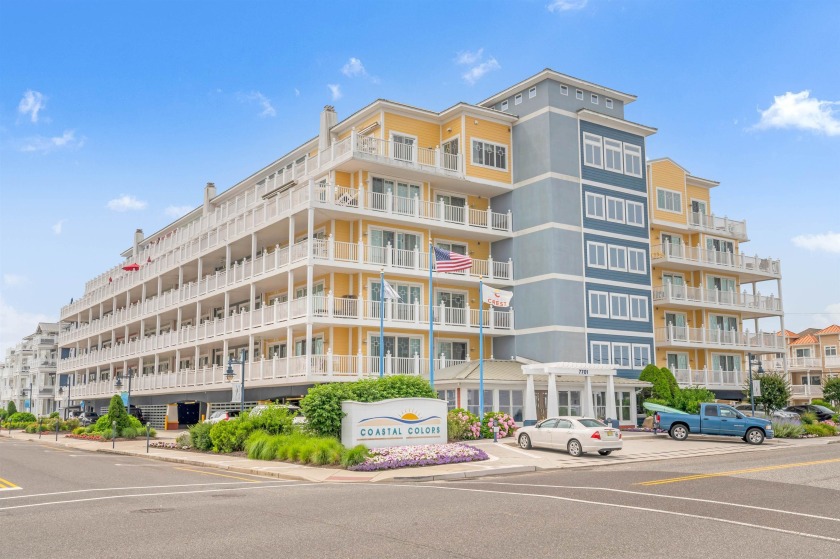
top-left (59, 70), bottom-right (654, 423)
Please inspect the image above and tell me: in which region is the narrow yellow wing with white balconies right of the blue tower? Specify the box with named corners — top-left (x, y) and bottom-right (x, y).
top-left (647, 158), bottom-right (784, 400)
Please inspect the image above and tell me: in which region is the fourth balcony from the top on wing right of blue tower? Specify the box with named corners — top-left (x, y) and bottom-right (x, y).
top-left (656, 325), bottom-right (784, 353)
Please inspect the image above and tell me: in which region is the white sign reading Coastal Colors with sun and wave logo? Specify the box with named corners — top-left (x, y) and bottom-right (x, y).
top-left (341, 398), bottom-right (446, 448)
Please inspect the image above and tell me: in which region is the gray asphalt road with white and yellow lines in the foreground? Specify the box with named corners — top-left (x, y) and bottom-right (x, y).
top-left (0, 439), bottom-right (840, 559)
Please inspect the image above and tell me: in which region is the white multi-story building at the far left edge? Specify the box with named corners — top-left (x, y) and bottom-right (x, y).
top-left (0, 322), bottom-right (58, 416)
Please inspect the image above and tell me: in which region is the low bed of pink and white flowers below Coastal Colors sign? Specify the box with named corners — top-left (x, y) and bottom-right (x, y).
top-left (348, 443), bottom-right (488, 472)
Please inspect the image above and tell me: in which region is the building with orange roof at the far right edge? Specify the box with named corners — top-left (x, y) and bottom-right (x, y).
top-left (762, 324), bottom-right (840, 403)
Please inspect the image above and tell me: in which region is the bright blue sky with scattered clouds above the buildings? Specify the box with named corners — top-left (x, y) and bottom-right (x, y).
top-left (0, 0), bottom-right (840, 349)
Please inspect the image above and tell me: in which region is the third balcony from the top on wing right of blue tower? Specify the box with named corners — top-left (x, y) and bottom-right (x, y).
top-left (653, 284), bottom-right (783, 318)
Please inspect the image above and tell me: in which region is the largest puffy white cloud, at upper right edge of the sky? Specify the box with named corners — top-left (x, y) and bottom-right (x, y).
top-left (755, 89), bottom-right (840, 136)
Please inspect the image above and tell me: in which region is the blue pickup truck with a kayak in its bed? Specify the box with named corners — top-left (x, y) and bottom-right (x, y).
top-left (653, 404), bottom-right (773, 444)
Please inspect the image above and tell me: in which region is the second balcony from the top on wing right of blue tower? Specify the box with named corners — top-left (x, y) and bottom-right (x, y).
top-left (650, 243), bottom-right (782, 282)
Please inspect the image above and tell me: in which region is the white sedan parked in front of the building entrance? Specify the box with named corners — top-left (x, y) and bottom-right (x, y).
top-left (516, 417), bottom-right (623, 456)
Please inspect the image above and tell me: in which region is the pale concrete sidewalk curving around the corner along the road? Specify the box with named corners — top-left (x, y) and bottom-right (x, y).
top-left (0, 431), bottom-right (840, 482)
